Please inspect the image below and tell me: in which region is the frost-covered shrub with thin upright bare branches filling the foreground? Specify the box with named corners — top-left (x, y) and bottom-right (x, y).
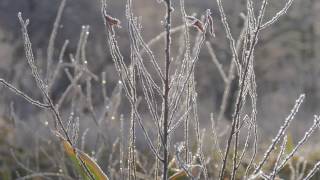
top-left (0, 0), bottom-right (320, 180)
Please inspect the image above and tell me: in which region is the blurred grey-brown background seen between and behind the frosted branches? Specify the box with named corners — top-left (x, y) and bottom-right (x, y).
top-left (0, 0), bottom-right (320, 174)
